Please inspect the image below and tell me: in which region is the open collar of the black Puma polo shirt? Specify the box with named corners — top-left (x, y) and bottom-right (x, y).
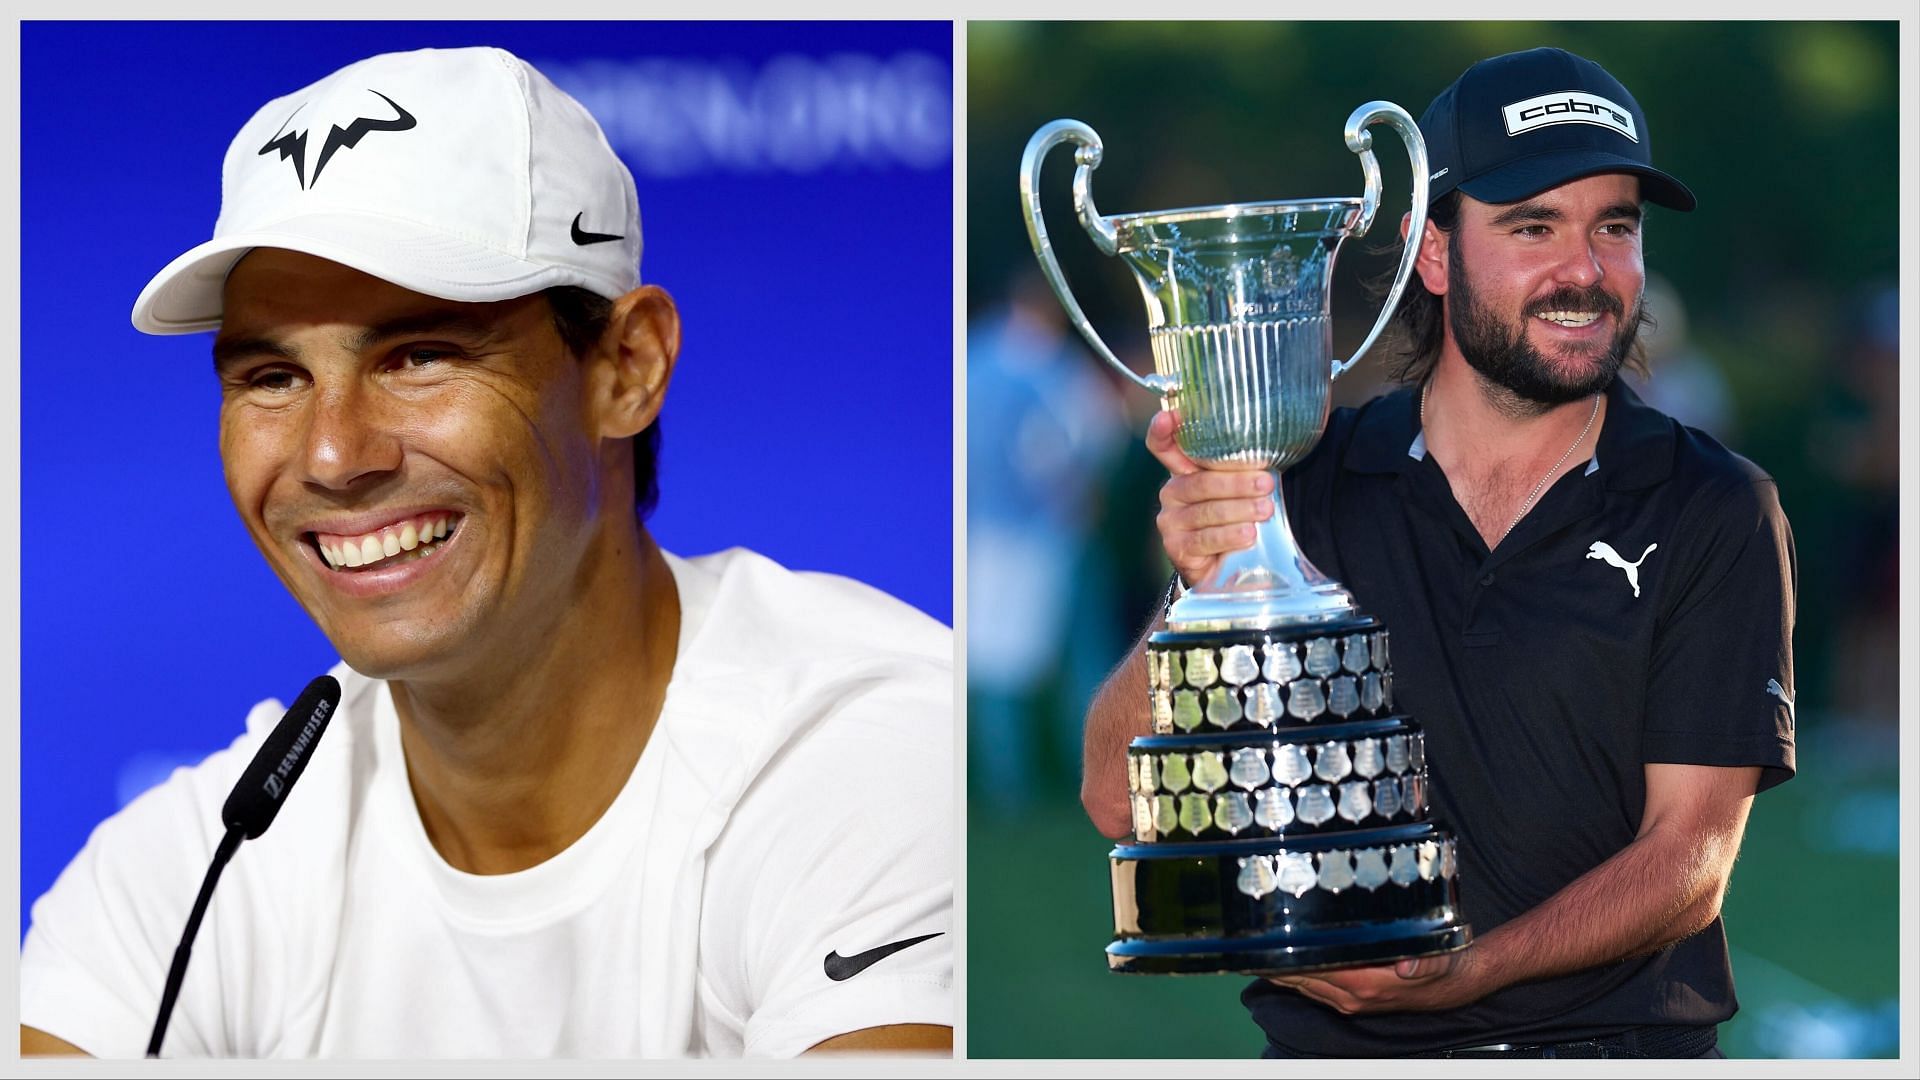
top-left (1346, 368), bottom-right (1674, 490)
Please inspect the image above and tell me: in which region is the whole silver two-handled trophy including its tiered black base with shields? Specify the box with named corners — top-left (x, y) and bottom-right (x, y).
top-left (1020, 102), bottom-right (1471, 974)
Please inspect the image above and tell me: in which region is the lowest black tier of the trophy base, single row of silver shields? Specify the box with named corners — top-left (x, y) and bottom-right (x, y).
top-left (1106, 822), bottom-right (1473, 974)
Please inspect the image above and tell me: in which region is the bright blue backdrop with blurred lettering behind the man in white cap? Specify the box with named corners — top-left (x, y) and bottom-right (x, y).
top-left (19, 23), bottom-right (952, 928)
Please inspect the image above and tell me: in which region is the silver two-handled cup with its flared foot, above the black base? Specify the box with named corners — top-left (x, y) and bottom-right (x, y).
top-left (1020, 102), bottom-right (1427, 630)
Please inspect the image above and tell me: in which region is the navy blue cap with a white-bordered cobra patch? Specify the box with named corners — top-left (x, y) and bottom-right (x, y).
top-left (1421, 48), bottom-right (1693, 209)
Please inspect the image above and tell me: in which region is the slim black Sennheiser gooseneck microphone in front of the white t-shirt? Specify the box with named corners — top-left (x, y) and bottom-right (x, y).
top-left (146, 675), bottom-right (340, 1057)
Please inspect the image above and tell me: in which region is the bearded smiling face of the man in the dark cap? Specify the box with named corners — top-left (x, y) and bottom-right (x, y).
top-left (1428, 173), bottom-right (1645, 405)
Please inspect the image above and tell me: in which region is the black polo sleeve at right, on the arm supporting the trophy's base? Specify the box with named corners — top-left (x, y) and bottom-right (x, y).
top-left (1642, 479), bottom-right (1797, 790)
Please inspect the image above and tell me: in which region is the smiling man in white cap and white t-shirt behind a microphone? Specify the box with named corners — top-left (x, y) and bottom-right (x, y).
top-left (21, 48), bottom-right (952, 1057)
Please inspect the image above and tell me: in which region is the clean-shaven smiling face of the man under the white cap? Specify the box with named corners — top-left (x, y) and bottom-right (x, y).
top-left (215, 248), bottom-right (632, 678)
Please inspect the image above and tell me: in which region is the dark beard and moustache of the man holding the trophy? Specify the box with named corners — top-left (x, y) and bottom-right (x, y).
top-left (1448, 248), bottom-right (1645, 411)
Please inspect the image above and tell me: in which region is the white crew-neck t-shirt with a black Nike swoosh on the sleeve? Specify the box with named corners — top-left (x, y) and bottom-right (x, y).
top-left (21, 550), bottom-right (954, 1057)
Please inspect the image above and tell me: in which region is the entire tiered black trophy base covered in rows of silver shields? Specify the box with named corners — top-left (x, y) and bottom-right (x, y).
top-left (1108, 615), bottom-right (1473, 974)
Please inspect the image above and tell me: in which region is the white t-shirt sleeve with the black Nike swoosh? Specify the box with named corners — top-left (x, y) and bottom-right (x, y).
top-left (699, 665), bottom-right (954, 1057)
